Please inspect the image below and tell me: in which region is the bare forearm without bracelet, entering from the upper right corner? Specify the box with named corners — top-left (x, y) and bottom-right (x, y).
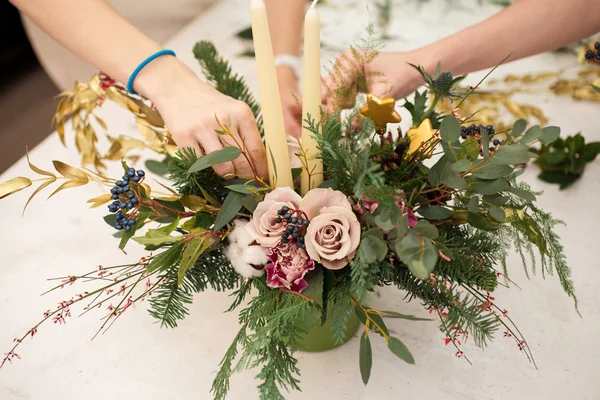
top-left (417, 0), bottom-right (600, 75)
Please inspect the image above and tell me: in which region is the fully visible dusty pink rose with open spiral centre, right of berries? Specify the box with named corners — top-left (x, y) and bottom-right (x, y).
top-left (300, 188), bottom-right (360, 270)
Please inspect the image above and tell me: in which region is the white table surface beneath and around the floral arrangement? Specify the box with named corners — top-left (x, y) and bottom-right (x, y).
top-left (0, 0), bottom-right (600, 400)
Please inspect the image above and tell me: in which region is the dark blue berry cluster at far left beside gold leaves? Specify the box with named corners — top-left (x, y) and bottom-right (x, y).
top-left (108, 168), bottom-right (146, 232)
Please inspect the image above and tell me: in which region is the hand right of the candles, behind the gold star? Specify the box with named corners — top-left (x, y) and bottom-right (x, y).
top-left (323, 51), bottom-right (428, 111)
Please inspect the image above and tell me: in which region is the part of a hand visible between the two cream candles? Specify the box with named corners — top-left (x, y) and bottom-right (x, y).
top-left (277, 65), bottom-right (302, 138)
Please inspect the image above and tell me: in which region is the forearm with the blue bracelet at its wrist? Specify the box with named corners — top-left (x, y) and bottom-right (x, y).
top-left (11, 0), bottom-right (191, 98)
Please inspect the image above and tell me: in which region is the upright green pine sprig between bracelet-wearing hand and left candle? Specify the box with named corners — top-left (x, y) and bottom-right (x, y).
top-left (194, 41), bottom-right (263, 136)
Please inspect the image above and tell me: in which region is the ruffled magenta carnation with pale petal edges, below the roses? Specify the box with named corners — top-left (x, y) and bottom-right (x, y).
top-left (265, 243), bottom-right (315, 293)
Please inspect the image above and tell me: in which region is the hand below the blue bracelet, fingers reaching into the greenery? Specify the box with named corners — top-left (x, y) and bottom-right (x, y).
top-left (135, 57), bottom-right (267, 179)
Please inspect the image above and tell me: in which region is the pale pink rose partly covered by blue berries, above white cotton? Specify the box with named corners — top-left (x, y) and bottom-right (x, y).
top-left (246, 187), bottom-right (302, 248)
